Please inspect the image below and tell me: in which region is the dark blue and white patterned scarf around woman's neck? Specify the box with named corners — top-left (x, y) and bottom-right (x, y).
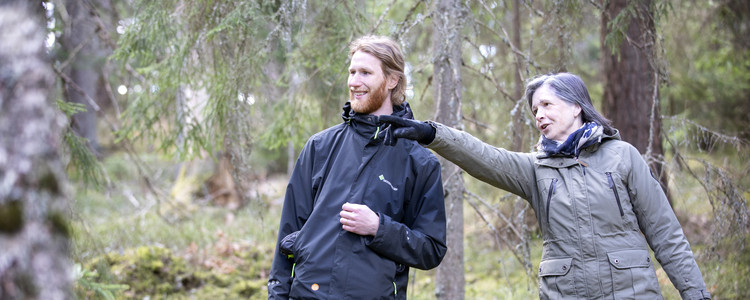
top-left (537, 122), bottom-right (604, 158)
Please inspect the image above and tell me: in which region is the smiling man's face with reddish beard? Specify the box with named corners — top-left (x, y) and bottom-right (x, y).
top-left (348, 51), bottom-right (391, 114)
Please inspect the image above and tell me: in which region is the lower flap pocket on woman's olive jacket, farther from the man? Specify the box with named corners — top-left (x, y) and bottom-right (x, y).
top-left (607, 249), bottom-right (661, 299)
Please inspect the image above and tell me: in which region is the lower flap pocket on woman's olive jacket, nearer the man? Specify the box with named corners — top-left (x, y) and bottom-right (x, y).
top-left (539, 257), bottom-right (576, 299)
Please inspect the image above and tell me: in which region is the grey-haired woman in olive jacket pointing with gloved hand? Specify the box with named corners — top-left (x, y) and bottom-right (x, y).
top-left (380, 73), bottom-right (710, 299)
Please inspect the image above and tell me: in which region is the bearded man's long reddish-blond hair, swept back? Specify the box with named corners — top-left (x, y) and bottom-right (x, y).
top-left (349, 35), bottom-right (406, 105)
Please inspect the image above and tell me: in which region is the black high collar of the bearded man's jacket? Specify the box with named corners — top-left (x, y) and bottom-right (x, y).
top-left (341, 101), bottom-right (414, 142)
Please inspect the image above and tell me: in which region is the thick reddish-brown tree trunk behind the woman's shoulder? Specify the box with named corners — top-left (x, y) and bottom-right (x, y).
top-left (601, 0), bottom-right (671, 203)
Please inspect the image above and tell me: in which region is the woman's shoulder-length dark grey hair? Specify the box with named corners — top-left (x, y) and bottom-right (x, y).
top-left (524, 73), bottom-right (615, 134)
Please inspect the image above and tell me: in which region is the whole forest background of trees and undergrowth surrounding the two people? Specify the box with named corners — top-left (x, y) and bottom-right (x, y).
top-left (0, 0), bottom-right (750, 299)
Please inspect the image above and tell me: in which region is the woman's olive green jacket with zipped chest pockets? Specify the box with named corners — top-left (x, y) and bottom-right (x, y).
top-left (426, 122), bottom-right (710, 299)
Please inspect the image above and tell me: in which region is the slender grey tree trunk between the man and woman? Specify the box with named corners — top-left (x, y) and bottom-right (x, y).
top-left (433, 0), bottom-right (467, 300)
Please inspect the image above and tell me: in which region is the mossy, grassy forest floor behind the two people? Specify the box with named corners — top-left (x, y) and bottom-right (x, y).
top-left (71, 155), bottom-right (750, 299)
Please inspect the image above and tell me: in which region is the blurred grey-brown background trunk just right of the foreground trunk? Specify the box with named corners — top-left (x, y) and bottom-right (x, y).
top-left (60, 0), bottom-right (109, 155)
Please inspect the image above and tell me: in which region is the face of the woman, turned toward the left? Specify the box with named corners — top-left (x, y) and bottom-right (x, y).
top-left (531, 83), bottom-right (583, 142)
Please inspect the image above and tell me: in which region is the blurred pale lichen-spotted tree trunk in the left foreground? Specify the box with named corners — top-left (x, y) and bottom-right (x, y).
top-left (0, 0), bottom-right (73, 299)
